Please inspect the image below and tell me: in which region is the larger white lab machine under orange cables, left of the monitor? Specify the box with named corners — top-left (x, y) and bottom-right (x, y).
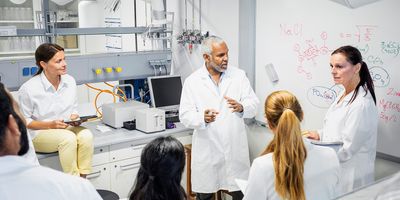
top-left (102, 101), bottom-right (149, 128)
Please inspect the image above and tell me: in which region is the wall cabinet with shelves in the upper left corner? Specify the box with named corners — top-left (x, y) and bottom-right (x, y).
top-left (0, 0), bottom-right (79, 57)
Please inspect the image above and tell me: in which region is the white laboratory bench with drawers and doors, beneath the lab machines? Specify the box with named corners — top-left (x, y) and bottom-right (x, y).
top-left (37, 121), bottom-right (193, 198)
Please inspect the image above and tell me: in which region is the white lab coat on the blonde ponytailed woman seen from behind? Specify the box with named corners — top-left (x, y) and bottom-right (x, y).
top-left (243, 139), bottom-right (340, 200)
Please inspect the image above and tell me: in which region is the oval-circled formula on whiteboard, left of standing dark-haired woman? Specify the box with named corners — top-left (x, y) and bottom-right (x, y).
top-left (307, 86), bottom-right (337, 108)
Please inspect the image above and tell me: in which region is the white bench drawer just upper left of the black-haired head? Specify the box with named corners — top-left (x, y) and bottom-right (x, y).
top-left (110, 142), bottom-right (146, 161)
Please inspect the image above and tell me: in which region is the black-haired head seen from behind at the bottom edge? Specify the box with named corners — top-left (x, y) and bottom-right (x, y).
top-left (129, 136), bottom-right (186, 200)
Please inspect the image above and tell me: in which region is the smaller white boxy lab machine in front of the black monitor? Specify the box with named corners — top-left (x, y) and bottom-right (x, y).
top-left (136, 108), bottom-right (165, 133)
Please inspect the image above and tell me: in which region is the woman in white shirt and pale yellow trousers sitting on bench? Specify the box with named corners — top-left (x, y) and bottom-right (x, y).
top-left (18, 43), bottom-right (93, 177)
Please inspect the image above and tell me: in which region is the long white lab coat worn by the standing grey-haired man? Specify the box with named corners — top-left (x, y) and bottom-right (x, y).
top-left (179, 65), bottom-right (259, 193)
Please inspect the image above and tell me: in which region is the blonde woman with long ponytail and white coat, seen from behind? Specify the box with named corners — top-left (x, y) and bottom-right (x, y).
top-left (244, 91), bottom-right (339, 200)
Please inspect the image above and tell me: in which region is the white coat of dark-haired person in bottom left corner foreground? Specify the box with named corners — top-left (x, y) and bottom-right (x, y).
top-left (0, 156), bottom-right (102, 200)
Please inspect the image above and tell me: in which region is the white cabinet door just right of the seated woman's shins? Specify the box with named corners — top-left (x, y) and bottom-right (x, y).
top-left (87, 164), bottom-right (111, 190)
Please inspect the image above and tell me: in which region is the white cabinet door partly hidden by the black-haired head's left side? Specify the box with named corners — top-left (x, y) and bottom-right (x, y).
top-left (111, 157), bottom-right (140, 199)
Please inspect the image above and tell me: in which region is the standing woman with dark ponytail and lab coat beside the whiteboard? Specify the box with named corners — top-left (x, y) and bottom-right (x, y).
top-left (309, 46), bottom-right (378, 193)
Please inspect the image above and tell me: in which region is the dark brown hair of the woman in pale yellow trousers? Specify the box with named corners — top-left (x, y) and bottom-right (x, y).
top-left (35, 43), bottom-right (64, 76)
